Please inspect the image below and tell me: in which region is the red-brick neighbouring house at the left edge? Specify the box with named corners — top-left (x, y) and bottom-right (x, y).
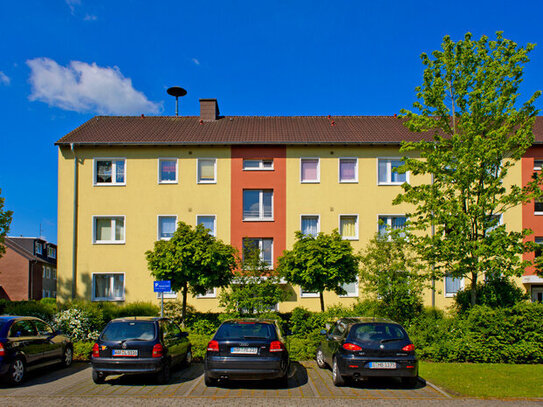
top-left (0, 237), bottom-right (57, 301)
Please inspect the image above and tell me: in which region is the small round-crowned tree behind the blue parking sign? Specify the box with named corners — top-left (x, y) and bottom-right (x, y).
top-left (145, 222), bottom-right (236, 322)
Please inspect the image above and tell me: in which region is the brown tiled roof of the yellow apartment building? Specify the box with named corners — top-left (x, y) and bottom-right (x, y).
top-left (56, 116), bottom-right (543, 145)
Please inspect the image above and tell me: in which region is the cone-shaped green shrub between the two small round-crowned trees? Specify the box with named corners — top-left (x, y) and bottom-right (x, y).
top-left (219, 245), bottom-right (286, 314)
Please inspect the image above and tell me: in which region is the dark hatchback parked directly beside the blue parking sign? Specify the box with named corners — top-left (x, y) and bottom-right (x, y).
top-left (91, 317), bottom-right (192, 384)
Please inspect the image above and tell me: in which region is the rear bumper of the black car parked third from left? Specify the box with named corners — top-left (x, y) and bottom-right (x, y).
top-left (204, 356), bottom-right (288, 380)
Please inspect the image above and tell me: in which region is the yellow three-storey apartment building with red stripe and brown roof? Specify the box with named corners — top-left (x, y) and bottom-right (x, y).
top-left (56, 99), bottom-right (543, 311)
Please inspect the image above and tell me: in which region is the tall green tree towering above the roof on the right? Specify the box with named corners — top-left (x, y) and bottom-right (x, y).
top-left (394, 32), bottom-right (541, 305)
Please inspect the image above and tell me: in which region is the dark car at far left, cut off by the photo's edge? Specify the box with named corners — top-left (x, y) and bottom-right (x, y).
top-left (0, 316), bottom-right (73, 385)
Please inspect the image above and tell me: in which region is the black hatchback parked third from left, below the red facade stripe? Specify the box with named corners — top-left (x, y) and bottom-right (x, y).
top-left (204, 319), bottom-right (289, 386)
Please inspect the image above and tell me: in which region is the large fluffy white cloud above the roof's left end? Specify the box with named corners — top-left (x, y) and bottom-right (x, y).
top-left (26, 58), bottom-right (162, 115)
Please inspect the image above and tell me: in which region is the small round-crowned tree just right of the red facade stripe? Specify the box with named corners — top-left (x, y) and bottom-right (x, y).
top-left (277, 229), bottom-right (359, 311)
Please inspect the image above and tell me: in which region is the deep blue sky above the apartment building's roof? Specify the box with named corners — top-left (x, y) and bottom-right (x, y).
top-left (0, 0), bottom-right (543, 242)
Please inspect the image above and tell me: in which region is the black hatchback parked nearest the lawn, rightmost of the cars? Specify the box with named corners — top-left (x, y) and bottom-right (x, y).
top-left (316, 318), bottom-right (418, 387)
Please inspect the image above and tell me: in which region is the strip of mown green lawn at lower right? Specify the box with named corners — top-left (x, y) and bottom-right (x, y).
top-left (419, 362), bottom-right (543, 399)
